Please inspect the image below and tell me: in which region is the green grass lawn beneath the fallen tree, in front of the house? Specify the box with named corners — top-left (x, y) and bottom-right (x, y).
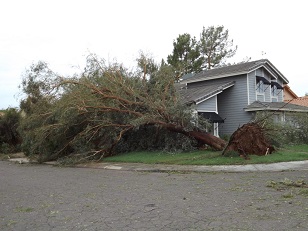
top-left (103, 144), bottom-right (308, 165)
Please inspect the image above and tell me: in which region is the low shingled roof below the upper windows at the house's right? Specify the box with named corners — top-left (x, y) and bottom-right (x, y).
top-left (244, 101), bottom-right (308, 112)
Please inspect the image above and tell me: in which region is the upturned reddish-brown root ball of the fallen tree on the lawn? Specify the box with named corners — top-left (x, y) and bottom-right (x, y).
top-left (222, 123), bottom-right (275, 158)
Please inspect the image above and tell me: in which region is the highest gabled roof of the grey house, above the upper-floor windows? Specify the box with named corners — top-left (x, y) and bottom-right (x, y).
top-left (183, 59), bottom-right (289, 83)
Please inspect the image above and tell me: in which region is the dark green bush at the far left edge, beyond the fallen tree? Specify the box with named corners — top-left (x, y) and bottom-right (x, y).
top-left (0, 108), bottom-right (21, 153)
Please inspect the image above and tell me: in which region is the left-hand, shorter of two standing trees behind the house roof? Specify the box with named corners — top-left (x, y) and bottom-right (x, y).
top-left (167, 34), bottom-right (203, 79)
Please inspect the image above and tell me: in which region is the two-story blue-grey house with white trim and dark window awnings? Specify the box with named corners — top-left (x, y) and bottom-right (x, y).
top-left (180, 59), bottom-right (308, 136)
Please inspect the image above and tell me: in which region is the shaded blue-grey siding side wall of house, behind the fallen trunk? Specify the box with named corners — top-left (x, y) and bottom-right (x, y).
top-left (188, 74), bottom-right (255, 136)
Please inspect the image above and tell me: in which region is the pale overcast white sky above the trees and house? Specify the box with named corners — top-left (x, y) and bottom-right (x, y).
top-left (0, 0), bottom-right (308, 109)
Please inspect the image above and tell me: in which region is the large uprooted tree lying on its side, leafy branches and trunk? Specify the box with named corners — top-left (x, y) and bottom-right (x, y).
top-left (20, 55), bottom-right (226, 161)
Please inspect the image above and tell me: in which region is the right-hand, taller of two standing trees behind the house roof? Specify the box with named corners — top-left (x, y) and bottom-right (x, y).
top-left (199, 26), bottom-right (237, 69)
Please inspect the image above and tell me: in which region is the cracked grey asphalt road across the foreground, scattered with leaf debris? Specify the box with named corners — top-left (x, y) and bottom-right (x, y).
top-left (0, 161), bottom-right (308, 231)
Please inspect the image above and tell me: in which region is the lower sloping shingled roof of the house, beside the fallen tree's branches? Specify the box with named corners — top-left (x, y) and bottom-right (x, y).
top-left (179, 81), bottom-right (235, 104)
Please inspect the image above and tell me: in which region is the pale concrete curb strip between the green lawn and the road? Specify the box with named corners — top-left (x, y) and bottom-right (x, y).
top-left (9, 158), bottom-right (308, 172)
